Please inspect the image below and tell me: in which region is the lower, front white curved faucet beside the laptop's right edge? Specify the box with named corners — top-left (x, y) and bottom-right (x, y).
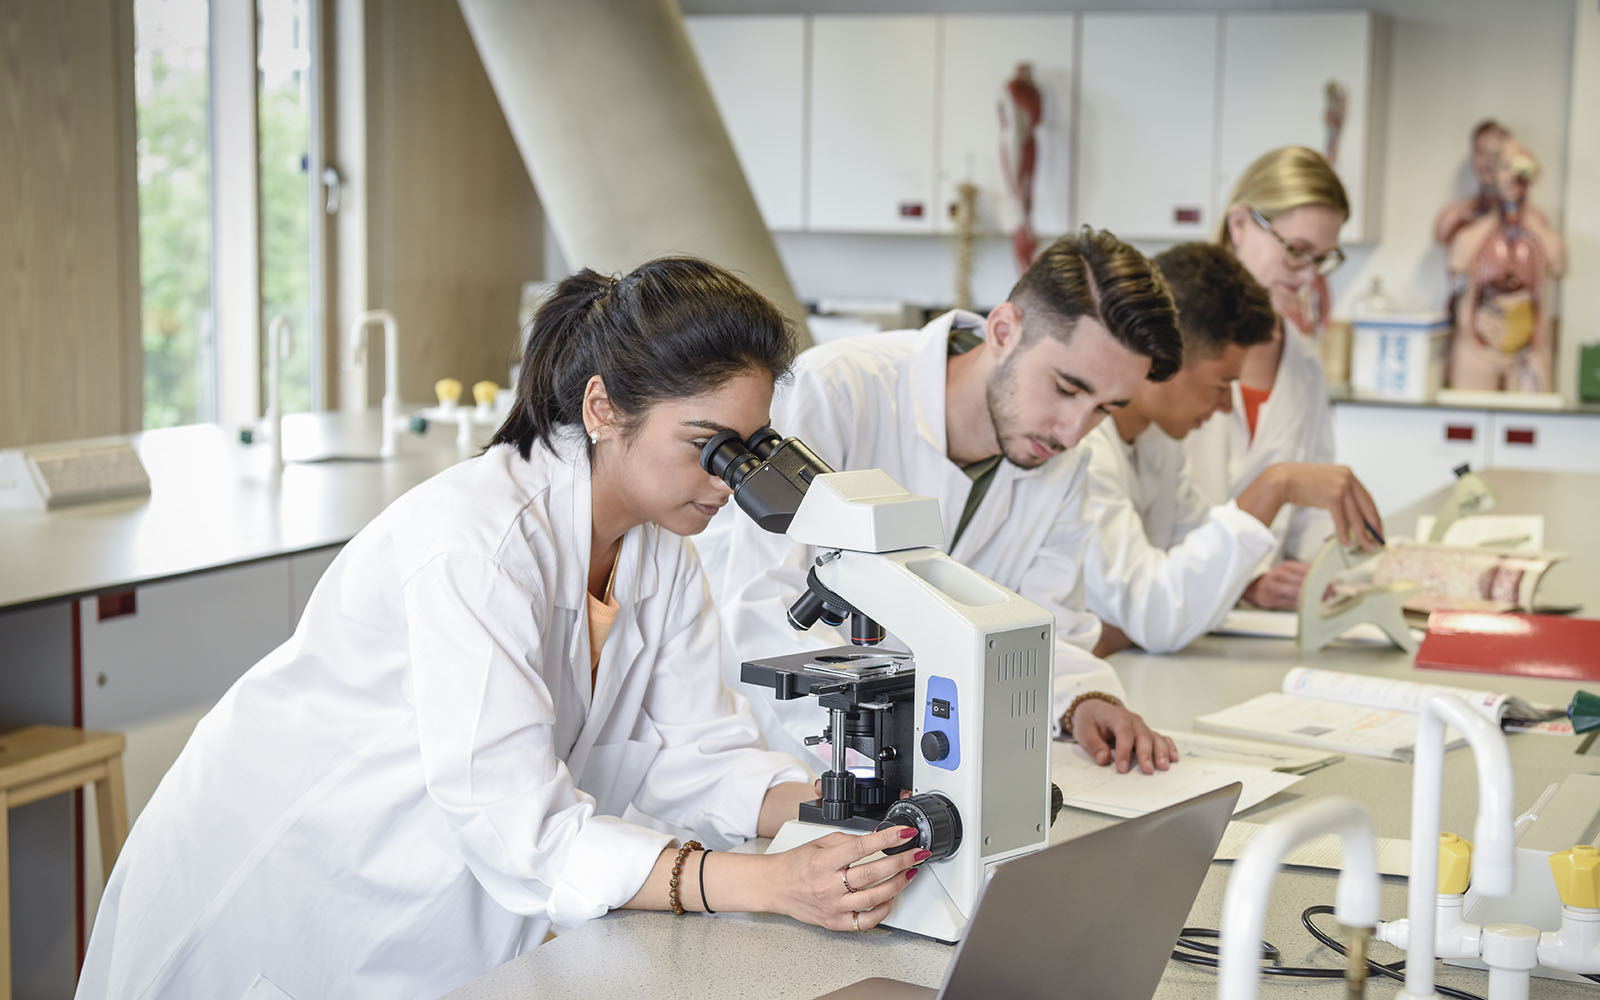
top-left (1218, 797), bottom-right (1378, 1000)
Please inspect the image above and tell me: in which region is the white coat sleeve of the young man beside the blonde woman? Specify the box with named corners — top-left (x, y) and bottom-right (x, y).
top-left (1083, 448), bottom-right (1277, 653)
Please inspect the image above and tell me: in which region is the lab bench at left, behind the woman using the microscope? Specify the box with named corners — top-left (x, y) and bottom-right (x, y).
top-left (0, 413), bottom-right (476, 997)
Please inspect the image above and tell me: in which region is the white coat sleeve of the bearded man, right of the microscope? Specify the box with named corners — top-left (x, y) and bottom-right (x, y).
top-left (1016, 459), bottom-right (1128, 734)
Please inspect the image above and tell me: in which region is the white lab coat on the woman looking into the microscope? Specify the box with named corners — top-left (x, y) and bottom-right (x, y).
top-left (77, 434), bottom-right (805, 1000)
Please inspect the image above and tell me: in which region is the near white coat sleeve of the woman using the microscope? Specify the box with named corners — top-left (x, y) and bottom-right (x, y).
top-left (403, 554), bottom-right (672, 926)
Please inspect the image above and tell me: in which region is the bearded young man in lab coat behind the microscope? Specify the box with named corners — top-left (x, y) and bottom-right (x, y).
top-left (694, 230), bottom-right (1181, 773)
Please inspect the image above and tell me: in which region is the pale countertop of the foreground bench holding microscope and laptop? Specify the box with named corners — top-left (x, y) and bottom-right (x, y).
top-left (448, 470), bottom-right (1600, 1000)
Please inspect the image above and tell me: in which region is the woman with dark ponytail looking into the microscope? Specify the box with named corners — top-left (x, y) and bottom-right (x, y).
top-left (78, 259), bottom-right (926, 997)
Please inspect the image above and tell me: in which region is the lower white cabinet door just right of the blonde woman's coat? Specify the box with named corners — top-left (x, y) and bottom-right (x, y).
top-left (1333, 403), bottom-right (1490, 518)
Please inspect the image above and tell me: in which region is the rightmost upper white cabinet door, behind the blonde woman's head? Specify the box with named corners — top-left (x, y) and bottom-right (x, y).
top-left (1214, 11), bottom-right (1384, 243)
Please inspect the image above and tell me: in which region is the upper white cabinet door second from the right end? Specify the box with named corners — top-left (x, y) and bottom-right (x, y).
top-left (1075, 14), bottom-right (1221, 240)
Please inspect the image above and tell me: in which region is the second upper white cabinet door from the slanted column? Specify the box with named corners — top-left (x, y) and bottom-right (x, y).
top-left (806, 14), bottom-right (939, 234)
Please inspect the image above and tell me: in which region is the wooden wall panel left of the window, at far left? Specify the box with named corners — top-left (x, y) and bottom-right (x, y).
top-left (0, 0), bottom-right (144, 446)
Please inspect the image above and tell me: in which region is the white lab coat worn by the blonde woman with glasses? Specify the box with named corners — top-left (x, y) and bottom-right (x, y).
top-left (1184, 326), bottom-right (1333, 574)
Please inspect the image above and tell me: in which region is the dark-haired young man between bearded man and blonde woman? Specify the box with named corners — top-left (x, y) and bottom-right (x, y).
top-left (1083, 243), bottom-right (1382, 656)
